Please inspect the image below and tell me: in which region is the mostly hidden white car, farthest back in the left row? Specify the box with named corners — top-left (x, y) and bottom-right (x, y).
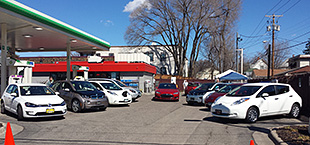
top-left (88, 78), bottom-right (142, 101)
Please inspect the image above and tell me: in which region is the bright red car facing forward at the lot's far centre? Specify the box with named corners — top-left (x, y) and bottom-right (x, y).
top-left (153, 83), bottom-right (180, 101)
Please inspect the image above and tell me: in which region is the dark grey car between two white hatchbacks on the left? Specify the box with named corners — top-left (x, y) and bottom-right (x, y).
top-left (52, 81), bottom-right (108, 112)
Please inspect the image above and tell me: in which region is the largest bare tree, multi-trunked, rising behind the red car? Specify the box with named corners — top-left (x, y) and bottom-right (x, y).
top-left (125, 0), bottom-right (239, 76)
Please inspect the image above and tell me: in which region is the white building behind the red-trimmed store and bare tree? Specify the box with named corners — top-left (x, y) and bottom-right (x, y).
top-left (96, 45), bottom-right (188, 77)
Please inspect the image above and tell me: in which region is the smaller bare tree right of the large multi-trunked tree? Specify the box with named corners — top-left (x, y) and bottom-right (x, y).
top-left (202, 0), bottom-right (241, 73)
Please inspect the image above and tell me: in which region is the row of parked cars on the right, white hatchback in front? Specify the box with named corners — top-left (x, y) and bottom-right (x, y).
top-left (186, 83), bottom-right (302, 123)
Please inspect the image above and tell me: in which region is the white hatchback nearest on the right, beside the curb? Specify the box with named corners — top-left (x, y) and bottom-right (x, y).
top-left (211, 83), bottom-right (302, 123)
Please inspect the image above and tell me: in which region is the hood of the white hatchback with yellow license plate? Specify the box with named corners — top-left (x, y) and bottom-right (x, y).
top-left (22, 95), bottom-right (64, 104)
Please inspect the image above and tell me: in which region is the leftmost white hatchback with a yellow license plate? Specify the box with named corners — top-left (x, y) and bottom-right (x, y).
top-left (1, 83), bottom-right (67, 120)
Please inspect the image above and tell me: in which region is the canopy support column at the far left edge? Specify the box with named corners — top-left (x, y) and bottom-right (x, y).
top-left (1, 23), bottom-right (8, 95)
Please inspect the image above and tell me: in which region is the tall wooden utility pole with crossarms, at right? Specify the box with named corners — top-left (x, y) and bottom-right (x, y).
top-left (265, 14), bottom-right (283, 78)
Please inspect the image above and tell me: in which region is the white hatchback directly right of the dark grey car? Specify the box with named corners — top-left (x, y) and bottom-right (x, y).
top-left (89, 81), bottom-right (132, 105)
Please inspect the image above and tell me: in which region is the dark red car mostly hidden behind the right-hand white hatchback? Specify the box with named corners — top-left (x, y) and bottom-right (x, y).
top-left (205, 83), bottom-right (243, 108)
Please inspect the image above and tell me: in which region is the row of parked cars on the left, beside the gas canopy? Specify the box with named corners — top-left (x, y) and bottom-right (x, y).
top-left (1, 79), bottom-right (141, 120)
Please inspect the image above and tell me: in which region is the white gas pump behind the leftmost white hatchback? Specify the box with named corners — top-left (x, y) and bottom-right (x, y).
top-left (6, 59), bottom-right (34, 84)
